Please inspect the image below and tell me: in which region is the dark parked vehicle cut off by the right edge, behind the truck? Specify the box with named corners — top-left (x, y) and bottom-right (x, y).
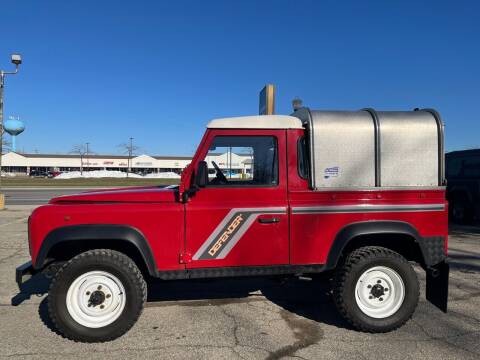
top-left (445, 149), bottom-right (480, 223)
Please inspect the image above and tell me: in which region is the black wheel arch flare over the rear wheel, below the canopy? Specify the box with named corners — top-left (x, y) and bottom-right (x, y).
top-left (326, 221), bottom-right (444, 269)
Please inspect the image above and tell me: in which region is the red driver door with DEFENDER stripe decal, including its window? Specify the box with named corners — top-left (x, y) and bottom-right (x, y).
top-left (186, 130), bottom-right (289, 268)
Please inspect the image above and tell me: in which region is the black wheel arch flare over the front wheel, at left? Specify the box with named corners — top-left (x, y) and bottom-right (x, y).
top-left (34, 224), bottom-right (158, 276)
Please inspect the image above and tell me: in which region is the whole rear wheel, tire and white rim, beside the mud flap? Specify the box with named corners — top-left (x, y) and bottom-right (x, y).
top-left (333, 246), bottom-right (420, 333)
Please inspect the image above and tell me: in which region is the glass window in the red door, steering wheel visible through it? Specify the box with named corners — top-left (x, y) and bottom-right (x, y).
top-left (204, 136), bottom-right (278, 186)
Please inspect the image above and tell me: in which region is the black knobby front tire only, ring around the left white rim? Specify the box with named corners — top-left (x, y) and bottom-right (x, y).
top-left (48, 249), bottom-right (147, 342)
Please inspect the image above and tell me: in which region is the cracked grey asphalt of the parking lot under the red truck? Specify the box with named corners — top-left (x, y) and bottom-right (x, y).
top-left (0, 207), bottom-right (480, 360)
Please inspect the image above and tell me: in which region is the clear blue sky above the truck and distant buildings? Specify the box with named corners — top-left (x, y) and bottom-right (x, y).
top-left (0, 0), bottom-right (480, 155)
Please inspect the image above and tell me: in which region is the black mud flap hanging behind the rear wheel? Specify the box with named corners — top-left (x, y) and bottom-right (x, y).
top-left (426, 259), bottom-right (450, 312)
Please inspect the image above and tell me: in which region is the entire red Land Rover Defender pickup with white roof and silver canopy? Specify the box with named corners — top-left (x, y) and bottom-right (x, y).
top-left (16, 108), bottom-right (449, 342)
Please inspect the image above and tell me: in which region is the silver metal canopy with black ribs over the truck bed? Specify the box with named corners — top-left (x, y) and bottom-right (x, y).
top-left (292, 108), bottom-right (444, 190)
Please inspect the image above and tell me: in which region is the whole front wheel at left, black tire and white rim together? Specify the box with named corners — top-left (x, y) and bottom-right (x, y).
top-left (48, 250), bottom-right (147, 342)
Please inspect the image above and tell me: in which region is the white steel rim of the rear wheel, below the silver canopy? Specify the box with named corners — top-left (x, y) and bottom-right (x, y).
top-left (355, 266), bottom-right (405, 319)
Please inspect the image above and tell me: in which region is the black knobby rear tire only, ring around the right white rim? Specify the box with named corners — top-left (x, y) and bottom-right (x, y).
top-left (333, 246), bottom-right (420, 333)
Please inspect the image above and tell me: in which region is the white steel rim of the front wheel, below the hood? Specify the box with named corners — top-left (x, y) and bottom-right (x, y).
top-left (66, 271), bottom-right (126, 328)
